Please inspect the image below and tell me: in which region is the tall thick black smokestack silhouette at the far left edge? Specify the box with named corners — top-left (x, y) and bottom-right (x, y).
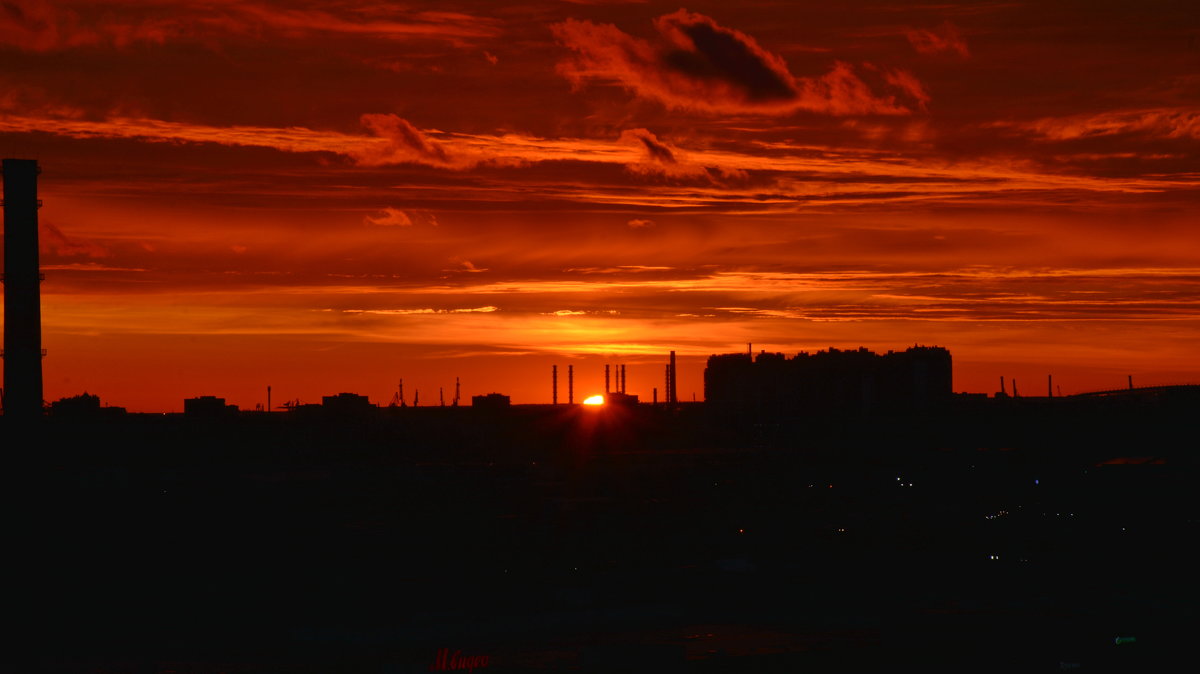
top-left (2, 160), bottom-right (43, 419)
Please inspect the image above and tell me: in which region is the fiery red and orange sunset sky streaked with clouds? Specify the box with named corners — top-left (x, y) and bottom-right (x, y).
top-left (0, 0), bottom-right (1200, 411)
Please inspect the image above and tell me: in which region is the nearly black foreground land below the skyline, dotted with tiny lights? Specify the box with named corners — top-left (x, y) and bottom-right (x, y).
top-left (11, 398), bottom-right (1200, 674)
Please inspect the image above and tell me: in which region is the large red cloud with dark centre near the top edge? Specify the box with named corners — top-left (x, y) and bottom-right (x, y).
top-left (552, 10), bottom-right (922, 115)
